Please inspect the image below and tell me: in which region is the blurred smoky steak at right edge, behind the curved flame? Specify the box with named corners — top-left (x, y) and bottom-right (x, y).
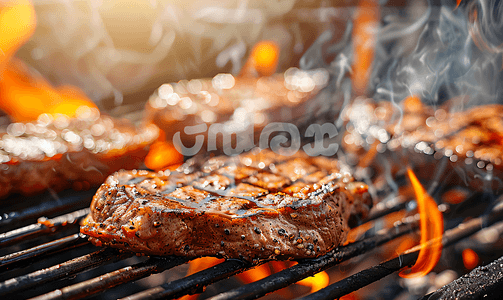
top-left (343, 98), bottom-right (503, 192)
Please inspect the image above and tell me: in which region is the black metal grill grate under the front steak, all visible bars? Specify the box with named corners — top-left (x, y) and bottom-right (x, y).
top-left (0, 189), bottom-right (503, 300)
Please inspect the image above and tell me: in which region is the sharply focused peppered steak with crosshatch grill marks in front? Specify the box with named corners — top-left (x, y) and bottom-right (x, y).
top-left (81, 150), bottom-right (372, 261)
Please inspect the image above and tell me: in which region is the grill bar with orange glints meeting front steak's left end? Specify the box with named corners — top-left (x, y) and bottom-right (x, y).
top-left (0, 208), bottom-right (90, 247)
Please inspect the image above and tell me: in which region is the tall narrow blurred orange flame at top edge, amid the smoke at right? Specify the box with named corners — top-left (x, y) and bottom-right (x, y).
top-left (352, 0), bottom-right (380, 95)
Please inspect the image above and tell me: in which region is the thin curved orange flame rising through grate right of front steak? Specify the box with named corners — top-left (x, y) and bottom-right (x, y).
top-left (399, 168), bottom-right (444, 278)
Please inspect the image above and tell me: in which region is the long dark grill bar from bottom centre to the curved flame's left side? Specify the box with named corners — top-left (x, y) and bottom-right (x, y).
top-left (210, 211), bottom-right (418, 300)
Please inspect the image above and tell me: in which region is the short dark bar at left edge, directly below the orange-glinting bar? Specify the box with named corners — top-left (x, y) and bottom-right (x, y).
top-left (0, 233), bottom-right (89, 271)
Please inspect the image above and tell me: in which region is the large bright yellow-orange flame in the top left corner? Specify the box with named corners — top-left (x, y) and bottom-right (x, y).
top-left (0, 0), bottom-right (96, 122)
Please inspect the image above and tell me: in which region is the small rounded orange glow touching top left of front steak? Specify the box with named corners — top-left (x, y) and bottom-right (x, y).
top-left (145, 132), bottom-right (183, 170)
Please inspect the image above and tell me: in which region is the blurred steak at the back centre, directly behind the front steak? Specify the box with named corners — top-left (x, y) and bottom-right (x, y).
top-left (146, 68), bottom-right (328, 149)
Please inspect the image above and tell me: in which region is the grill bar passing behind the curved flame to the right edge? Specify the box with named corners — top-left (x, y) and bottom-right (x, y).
top-left (300, 198), bottom-right (503, 300)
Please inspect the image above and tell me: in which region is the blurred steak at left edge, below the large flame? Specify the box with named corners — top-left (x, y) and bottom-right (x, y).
top-left (0, 110), bottom-right (159, 197)
